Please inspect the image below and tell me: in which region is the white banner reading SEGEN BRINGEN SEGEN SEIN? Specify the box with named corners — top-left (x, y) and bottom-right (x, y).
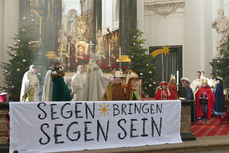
top-left (10, 100), bottom-right (182, 153)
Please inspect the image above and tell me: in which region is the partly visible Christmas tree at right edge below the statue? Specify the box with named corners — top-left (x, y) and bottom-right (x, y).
top-left (210, 39), bottom-right (229, 88)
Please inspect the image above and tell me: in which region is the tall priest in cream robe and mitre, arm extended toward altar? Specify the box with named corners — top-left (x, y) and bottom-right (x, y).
top-left (84, 52), bottom-right (112, 101)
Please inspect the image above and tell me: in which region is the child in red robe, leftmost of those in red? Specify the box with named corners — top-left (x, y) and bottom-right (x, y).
top-left (155, 81), bottom-right (171, 100)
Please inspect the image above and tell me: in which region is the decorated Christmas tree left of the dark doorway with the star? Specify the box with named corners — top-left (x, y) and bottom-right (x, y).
top-left (128, 28), bottom-right (156, 97)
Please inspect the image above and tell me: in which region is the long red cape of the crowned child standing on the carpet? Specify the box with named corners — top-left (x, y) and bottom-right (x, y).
top-left (195, 86), bottom-right (215, 119)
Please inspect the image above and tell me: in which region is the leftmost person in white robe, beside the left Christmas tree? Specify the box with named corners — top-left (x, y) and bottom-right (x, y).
top-left (20, 65), bottom-right (40, 102)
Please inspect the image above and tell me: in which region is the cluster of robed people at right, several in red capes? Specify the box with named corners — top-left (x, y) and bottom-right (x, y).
top-left (155, 71), bottom-right (225, 124)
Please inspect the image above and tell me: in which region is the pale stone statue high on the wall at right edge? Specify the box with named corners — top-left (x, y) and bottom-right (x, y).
top-left (212, 9), bottom-right (229, 55)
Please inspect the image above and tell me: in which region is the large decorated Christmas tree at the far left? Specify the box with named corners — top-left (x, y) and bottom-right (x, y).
top-left (1, 23), bottom-right (41, 101)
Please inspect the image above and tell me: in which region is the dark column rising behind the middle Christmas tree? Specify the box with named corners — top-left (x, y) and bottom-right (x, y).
top-left (119, 0), bottom-right (137, 55)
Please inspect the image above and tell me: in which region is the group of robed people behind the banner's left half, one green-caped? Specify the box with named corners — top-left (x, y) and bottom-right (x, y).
top-left (20, 52), bottom-right (113, 102)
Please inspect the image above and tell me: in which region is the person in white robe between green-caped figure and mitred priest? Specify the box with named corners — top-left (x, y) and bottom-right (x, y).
top-left (71, 65), bottom-right (85, 101)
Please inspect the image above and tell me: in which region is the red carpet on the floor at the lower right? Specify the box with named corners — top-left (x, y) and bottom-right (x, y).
top-left (191, 117), bottom-right (229, 137)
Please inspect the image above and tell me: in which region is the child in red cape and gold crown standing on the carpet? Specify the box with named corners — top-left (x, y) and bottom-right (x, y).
top-left (195, 79), bottom-right (215, 124)
